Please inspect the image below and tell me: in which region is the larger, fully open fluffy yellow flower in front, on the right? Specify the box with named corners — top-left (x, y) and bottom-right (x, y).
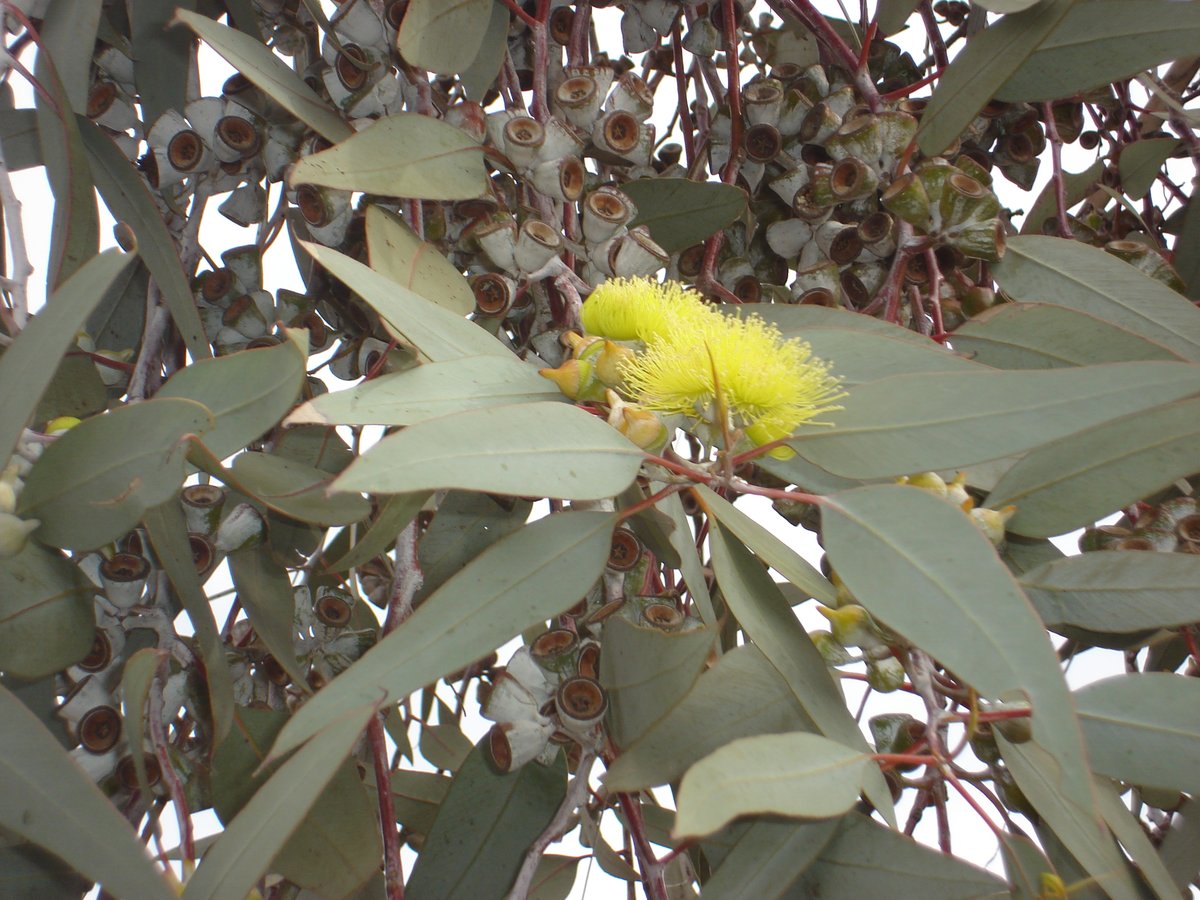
top-left (623, 312), bottom-right (844, 445)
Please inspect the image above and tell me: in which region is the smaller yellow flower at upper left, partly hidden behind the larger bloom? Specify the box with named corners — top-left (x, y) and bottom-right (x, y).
top-left (582, 278), bottom-right (718, 342)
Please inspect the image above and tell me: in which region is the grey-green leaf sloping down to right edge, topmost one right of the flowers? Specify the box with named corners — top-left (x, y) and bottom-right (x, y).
top-left (994, 235), bottom-right (1200, 360)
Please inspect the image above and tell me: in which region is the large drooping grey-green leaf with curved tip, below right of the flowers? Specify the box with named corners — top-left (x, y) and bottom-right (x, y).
top-left (821, 485), bottom-right (1128, 900)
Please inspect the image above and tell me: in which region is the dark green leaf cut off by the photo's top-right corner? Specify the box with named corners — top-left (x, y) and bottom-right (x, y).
top-left (996, 0), bottom-right (1200, 101)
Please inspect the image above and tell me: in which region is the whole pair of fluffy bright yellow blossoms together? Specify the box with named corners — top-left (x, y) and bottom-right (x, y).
top-left (547, 278), bottom-right (844, 455)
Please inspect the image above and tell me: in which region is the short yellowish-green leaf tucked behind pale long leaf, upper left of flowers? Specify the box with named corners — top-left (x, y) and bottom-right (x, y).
top-left (367, 204), bottom-right (475, 316)
